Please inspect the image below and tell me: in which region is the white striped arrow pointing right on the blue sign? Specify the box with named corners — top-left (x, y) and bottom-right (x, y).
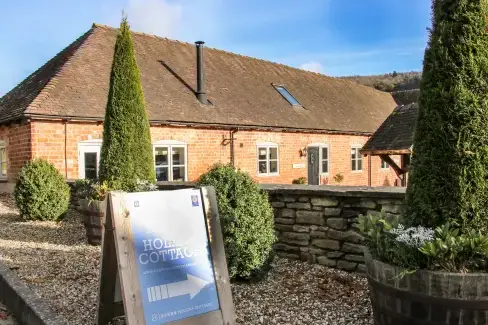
top-left (147, 274), bottom-right (211, 302)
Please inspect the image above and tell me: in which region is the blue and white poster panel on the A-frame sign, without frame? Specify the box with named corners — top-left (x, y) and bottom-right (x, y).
top-left (125, 189), bottom-right (219, 325)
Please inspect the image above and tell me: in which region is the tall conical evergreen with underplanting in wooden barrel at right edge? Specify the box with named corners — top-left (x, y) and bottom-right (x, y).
top-left (360, 0), bottom-right (488, 325)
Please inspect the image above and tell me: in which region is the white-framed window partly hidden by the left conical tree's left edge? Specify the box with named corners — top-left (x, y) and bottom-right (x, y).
top-left (78, 139), bottom-right (102, 179)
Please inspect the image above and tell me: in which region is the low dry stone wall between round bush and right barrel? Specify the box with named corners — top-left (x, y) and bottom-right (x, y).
top-left (262, 185), bottom-right (405, 272)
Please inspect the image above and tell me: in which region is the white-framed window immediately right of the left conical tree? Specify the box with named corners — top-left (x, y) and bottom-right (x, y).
top-left (153, 140), bottom-right (188, 182)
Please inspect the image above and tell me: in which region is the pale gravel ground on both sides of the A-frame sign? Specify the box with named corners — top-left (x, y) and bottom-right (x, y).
top-left (0, 194), bottom-right (372, 325)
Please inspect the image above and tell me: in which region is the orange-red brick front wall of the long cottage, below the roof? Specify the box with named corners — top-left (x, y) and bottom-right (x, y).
top-left (23, 121), bottom-right (396, 186)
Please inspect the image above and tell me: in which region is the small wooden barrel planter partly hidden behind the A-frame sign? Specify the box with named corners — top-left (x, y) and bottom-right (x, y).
top-left (79, 199), bottom-right (105, 245)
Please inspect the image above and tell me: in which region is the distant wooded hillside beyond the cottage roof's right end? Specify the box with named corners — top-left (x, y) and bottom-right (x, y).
top-left (341, 71), bottom-right (421, 92)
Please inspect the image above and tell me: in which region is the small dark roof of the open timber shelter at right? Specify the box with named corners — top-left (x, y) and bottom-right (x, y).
top-left (361, 103), bottom-right (418, 153)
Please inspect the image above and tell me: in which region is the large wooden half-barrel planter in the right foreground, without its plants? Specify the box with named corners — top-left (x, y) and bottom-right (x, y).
top-left (364, 251), bottom-right (488, 325)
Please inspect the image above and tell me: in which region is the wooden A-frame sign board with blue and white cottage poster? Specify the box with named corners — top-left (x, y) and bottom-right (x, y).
top-left (97, 187), bottom-right (235, 325)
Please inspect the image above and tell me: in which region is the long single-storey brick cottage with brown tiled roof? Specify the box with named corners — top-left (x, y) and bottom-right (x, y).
top-left (0, 25), bottom-right (396, 191)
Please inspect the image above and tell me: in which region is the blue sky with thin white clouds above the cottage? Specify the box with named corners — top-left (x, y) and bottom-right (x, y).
top-left (0, 0), bottom-right (430, 96)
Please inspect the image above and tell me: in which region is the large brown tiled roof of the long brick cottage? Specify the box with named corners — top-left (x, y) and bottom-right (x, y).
top-left (0, 25), bottom-right (396, 133)
